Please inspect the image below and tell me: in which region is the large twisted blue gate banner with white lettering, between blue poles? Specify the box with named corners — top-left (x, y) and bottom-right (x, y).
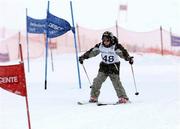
top-left (27, 12), bottom-right (72, 38)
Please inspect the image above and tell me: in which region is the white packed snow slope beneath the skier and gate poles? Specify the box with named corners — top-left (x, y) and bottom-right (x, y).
top-left (0, 53), bottom-right (180, 129)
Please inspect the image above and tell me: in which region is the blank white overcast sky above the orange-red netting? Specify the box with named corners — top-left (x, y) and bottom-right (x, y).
top-left (0, 0), bottom-right (180, 35)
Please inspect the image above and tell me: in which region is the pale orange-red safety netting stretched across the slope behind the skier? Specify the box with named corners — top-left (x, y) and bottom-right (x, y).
top-left (0, 25), bottom-right (180, 62)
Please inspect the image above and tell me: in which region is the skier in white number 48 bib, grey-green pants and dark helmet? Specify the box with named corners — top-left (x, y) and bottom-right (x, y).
top-left (79, 31), bottom-right (134, 103)
